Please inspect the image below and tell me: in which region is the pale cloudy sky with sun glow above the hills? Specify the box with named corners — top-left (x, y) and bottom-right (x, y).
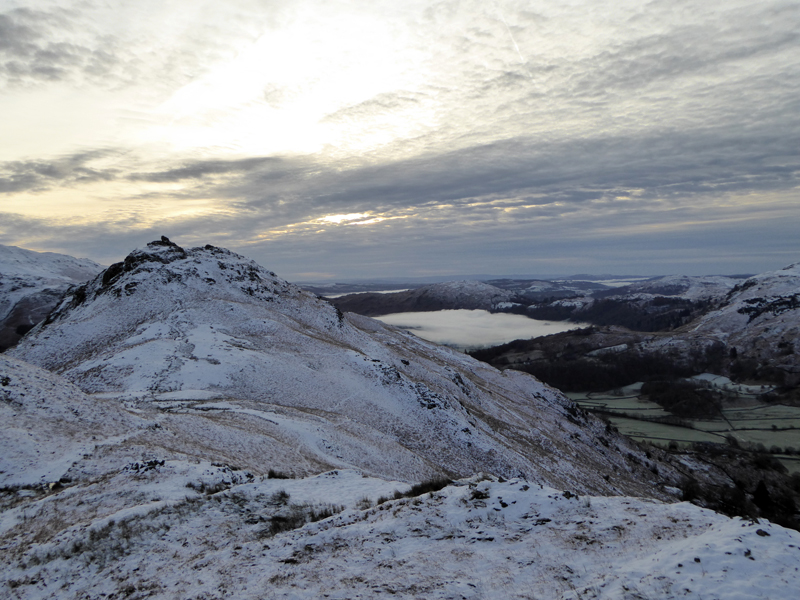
top-left (0, 0), bottom-right (800, 281)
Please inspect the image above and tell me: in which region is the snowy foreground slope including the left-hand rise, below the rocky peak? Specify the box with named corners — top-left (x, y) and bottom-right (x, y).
top-left (0, 356), bottom-right (800, 600)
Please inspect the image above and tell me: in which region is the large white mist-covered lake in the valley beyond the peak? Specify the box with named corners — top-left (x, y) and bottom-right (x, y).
top-left (375, 309), bottom-right (588, 350)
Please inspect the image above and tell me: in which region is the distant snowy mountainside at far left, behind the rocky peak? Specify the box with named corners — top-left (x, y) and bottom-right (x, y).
top-left (0, 245), bottom-right (103, 352)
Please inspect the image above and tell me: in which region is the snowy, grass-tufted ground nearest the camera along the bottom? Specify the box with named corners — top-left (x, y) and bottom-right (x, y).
top-left (2, 462), bottom-right (800, 599)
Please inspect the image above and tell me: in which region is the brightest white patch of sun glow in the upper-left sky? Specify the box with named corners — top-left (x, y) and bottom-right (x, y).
top-left (142, 14), bottom-right (432, 155)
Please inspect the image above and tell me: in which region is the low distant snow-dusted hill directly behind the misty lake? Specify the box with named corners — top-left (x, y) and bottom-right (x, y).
top-left (331, 281), bottom-right (514, 317)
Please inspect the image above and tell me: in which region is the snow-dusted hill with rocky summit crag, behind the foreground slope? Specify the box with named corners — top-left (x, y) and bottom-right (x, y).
top-left (11, 240), bottom-right (678, 496)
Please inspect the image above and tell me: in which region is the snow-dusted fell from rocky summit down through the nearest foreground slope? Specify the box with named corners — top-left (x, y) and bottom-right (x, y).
top-left (0, 239), bottom-right (800, 600)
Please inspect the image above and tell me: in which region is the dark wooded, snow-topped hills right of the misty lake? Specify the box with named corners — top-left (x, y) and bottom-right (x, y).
top-left (474, 263), bottom-right (800, 390)
